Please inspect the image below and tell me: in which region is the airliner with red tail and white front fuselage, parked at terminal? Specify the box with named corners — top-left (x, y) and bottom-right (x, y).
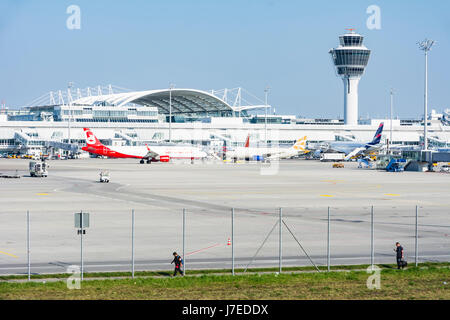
top-left (81, 128), bottom-right (207, 163)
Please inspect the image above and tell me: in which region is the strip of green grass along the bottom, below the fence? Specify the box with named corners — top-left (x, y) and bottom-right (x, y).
top-left (0, 266), bottom-right (450, 300)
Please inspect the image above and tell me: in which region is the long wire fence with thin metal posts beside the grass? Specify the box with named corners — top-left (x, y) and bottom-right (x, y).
top-left (0, 204), bottom-right (450, 275)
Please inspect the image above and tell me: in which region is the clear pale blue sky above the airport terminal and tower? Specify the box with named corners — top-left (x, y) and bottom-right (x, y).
top-left (0, 0), bottom-right (450, 118)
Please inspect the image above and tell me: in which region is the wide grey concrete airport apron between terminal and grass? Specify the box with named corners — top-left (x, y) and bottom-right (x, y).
top-left (0, 159), bottom-right (450, 274)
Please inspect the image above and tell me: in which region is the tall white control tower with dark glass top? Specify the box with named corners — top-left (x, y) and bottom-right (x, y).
top-left (330, 29), bottom-right (370, 125)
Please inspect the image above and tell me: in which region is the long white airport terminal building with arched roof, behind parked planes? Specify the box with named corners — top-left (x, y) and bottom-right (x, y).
top-left (0, 86), bottom-right (450, 154)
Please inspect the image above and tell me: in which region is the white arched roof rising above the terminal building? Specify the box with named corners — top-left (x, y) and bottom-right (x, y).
top-left (73, 89), bottom-right (265, 114)
